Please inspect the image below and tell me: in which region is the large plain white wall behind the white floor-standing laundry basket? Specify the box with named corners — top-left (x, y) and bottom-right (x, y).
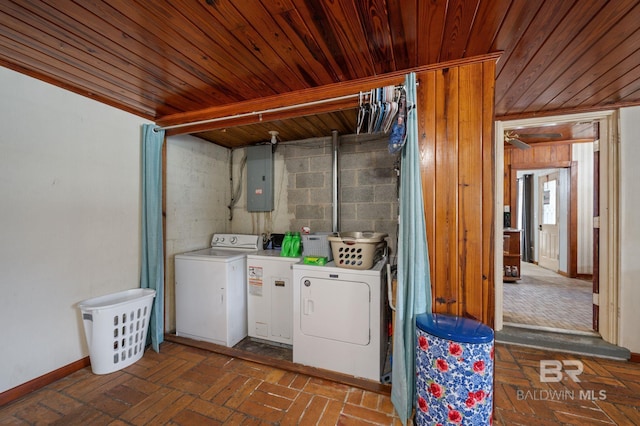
top-left (0, 68), bottom-right (146, 392)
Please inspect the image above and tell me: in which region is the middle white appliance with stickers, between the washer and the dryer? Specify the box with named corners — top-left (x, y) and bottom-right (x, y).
top-left (247, 250), bottom-right (300, 345)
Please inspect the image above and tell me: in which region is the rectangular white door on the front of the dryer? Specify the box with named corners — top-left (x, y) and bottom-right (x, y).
top-left (299, 277), bottom-right (371, 345)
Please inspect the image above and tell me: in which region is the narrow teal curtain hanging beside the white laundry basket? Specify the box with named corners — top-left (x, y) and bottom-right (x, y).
top-left (140, 124), bottom-right (164, 352)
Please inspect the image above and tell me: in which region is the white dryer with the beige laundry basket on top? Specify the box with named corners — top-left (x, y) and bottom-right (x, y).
top-left (293, 258), bottom-right (389, 382)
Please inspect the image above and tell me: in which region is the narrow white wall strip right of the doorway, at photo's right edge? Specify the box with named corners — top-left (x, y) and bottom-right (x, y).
top-left (619, 107), bottom-right (640, 353)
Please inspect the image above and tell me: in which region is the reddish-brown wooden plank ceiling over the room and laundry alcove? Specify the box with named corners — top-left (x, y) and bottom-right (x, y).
top-left (0, 0), bottom-right (640, 147)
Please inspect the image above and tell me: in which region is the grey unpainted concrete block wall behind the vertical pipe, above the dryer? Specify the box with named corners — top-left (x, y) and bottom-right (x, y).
top-left (278, 135), bottom-right (399, 256)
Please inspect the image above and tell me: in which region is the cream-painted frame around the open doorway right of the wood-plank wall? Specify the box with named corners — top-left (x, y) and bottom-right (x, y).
top-left (494, 110), bottom-right (620, 344)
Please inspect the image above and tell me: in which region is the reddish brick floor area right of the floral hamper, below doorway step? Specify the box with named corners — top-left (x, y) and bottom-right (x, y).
top-left (494, 345), bottom-right (640, 426)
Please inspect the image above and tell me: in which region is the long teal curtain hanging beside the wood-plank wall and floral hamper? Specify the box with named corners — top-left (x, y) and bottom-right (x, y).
top-left (391, 73), bottom-right (431, 425)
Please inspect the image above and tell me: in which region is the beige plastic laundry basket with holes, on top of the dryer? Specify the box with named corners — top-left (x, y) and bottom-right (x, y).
top-left (328, 231), bottom-right (387, 269)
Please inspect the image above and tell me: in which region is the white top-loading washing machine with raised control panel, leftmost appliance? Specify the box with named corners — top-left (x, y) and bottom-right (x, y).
top-left (175, 234), bottom-right (261, 347)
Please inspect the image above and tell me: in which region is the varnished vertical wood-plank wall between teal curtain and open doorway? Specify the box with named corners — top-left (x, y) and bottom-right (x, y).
top-left (417, 60), bottom-right (496, 326)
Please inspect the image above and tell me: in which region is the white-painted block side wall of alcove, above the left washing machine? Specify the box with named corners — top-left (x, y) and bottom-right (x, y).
top-left (165, 135), bottom-right (231, 331)
